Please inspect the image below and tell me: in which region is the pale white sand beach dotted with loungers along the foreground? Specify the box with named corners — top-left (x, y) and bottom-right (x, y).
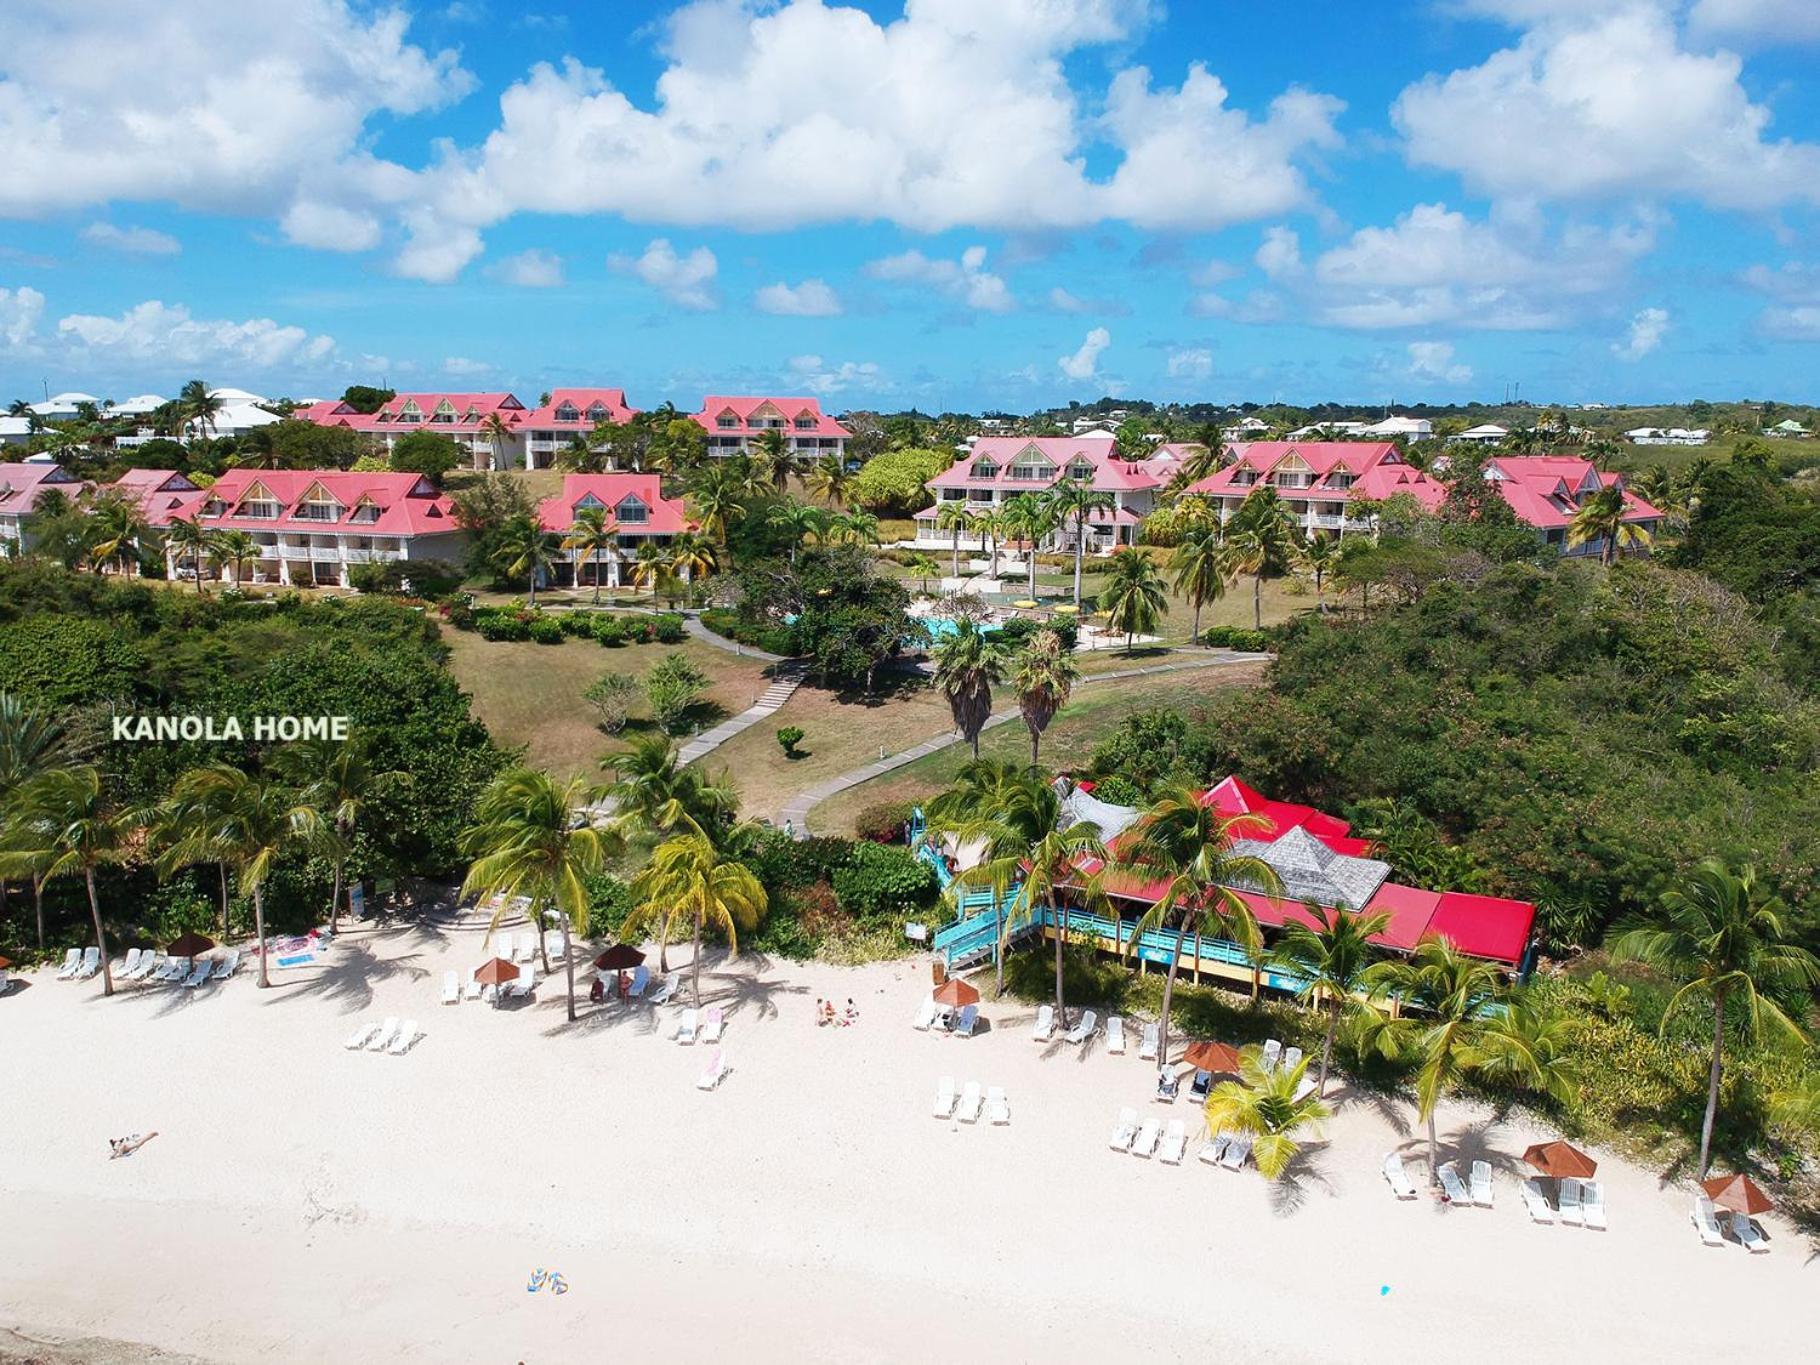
top-left (0, 925), bottom-right (1820, 1365)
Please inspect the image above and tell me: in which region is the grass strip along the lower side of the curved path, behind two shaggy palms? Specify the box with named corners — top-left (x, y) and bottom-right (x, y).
top-left (804, 664), bottom-right (1263, 834)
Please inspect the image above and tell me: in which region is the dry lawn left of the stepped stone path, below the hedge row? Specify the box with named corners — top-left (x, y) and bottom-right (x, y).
top-left (442, 630), bottom-right (777, 779)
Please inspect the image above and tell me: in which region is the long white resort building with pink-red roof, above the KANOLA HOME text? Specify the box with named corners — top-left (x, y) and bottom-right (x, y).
top-left (147, 470), bottom-right (468, 588)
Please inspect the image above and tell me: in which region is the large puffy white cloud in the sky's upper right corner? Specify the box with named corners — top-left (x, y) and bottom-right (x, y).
top-left (1390, 4), bottom-right (1820, 209)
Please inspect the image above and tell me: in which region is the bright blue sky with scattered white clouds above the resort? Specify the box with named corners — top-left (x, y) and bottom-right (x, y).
top-left (0, 0), bottom-right (1820, 411)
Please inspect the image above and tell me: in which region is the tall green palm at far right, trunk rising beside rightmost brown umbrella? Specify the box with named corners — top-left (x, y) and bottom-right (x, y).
top-left (1613, 857), bottom-right (1820, 1176)
